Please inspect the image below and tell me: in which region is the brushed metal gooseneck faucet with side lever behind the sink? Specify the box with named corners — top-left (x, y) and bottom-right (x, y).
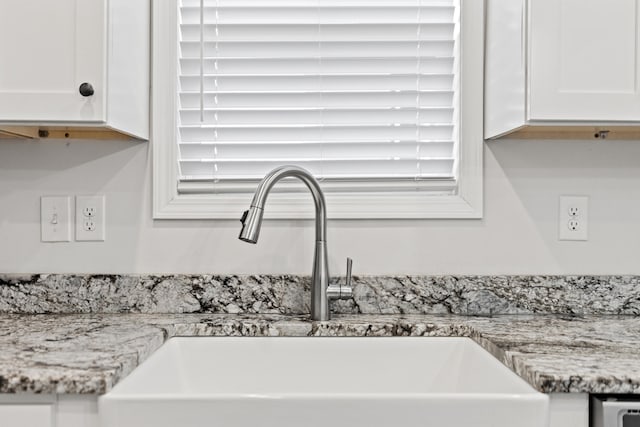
top-left (239, 166), bottom-right (352, 320)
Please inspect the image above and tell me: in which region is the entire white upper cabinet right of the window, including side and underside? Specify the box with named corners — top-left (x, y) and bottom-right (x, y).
top-left (485, 0), bottom-right (640, 138)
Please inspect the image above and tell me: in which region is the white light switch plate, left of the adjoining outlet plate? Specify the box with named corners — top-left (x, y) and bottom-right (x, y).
top-left (40, 196), bottom-right (71, 242)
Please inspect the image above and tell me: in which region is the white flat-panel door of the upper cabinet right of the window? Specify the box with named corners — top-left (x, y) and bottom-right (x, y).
top-left (528, 0), bottom-right (640, 121)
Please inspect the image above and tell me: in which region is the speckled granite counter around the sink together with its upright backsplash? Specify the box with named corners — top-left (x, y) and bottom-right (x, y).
top-left (0, 274), bottom-right (640, 394)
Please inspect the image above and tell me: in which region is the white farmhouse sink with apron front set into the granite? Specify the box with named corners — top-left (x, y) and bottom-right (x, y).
top-left (99, 337), bottom-right (549, 427)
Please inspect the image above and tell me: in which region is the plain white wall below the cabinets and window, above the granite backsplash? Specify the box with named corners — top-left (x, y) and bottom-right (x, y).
top-left (0, 141), bottom-right (640, 274)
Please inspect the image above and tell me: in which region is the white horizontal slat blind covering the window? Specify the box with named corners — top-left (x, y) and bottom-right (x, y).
top-left (177, 0), bottom-right (459, 193)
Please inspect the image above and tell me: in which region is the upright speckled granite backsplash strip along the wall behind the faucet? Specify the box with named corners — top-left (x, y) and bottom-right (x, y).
top-left (0, 274), bottom-right (640, 316)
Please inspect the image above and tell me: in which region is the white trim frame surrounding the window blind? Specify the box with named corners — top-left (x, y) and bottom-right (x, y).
top-left (151, 0), bottom-right (484, 219)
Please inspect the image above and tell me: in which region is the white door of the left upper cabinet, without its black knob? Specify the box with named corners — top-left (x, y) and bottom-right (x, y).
top-left (0, 0), bottom-right (106, 122)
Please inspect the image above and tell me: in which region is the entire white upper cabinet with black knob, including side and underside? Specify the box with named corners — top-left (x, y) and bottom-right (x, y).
top-left (0, 0), bottom-right (150, 139)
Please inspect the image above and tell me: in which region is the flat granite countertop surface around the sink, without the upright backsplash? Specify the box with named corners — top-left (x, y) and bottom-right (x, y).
top-left (0, 313), bottom-right (640, 394)
